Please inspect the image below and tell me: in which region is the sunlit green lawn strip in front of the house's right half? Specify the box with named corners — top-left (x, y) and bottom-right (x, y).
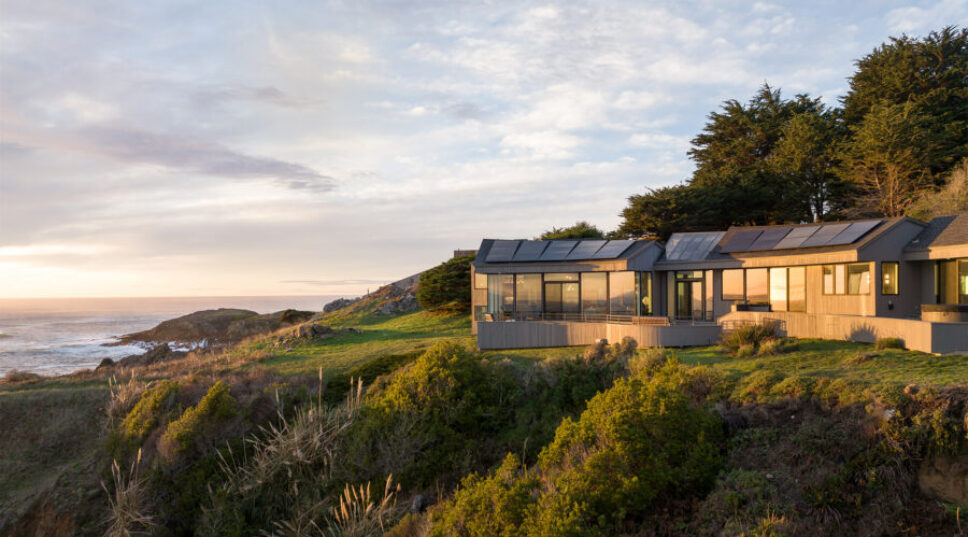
top-left (673, 339), bottom-right (968, 386)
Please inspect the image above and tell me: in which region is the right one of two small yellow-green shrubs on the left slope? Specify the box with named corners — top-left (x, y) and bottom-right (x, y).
top-left (159, 381), bottom-right (238, 460)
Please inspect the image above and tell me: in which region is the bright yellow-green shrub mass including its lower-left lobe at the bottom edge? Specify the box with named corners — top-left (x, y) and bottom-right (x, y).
top-left (432, 363), bottom-right (722, 537)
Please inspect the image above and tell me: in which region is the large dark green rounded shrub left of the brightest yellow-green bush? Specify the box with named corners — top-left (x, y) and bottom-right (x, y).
top-left (350, 343), bottom-right (519, 486)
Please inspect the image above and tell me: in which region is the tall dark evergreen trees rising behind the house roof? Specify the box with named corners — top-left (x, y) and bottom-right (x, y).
top-left (615, 27), bottom-right (968, 239)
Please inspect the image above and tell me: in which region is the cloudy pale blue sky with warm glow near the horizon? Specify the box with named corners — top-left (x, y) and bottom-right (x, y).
top-left (0, 0), bottom-right (968, 298)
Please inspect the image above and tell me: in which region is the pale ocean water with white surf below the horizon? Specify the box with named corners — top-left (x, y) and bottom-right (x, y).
top-left (0, 296), bottom-right (338, 376)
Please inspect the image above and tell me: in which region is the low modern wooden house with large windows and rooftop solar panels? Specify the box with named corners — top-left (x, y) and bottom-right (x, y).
top-left (471, 214), bottom-right (968, 354)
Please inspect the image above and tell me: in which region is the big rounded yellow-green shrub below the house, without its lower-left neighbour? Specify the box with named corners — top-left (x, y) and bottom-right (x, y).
top-left (526, 363), bottom-right (722, 536)
